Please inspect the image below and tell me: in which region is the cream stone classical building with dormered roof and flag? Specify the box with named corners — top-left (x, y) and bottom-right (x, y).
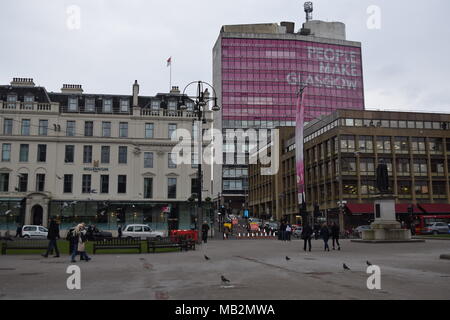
top-left (0, 78), bottom-right (212, 229)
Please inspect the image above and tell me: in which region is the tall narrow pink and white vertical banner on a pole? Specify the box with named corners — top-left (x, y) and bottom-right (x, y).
top-left (295, 88), bottom-right (306, 204)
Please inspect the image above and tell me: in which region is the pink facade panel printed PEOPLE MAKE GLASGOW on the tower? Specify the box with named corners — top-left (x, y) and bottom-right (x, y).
top-left (222, 38), bottom-right (364, 123)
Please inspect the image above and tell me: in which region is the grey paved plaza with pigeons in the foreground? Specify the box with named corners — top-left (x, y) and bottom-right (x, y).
top-left (0, 240), bottom-right (450, 300)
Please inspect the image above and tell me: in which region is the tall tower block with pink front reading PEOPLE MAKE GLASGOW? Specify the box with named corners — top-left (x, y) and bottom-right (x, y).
top-left (213, 13), bottom-right (364, 210)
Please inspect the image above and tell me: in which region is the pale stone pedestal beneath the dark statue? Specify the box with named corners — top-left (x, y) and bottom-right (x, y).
top-left (362, 197), bottom-right (411, 242)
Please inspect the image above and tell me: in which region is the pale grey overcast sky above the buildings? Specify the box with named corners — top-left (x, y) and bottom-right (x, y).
top-left (0, 0), bottom-right (450, 112)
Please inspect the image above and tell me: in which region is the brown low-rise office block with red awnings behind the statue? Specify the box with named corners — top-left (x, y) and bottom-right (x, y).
top-left (250, 110), bottom-right (450, 228)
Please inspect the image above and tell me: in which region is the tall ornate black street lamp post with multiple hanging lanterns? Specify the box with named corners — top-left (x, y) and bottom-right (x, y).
top-left (180, 81), bottom-right (220, 243)
